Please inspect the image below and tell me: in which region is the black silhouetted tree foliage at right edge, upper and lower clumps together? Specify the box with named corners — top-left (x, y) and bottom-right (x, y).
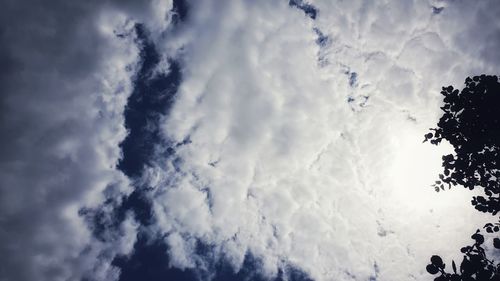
top-left (424, 74), bottom-right (500, 281)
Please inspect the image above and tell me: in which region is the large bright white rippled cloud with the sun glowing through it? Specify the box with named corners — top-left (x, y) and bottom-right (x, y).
top-left (146, 1), bottom-right (498, 280)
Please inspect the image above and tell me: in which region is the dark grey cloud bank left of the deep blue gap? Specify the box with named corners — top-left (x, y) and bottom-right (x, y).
top-left (0, 1), bottom-right (168, 280)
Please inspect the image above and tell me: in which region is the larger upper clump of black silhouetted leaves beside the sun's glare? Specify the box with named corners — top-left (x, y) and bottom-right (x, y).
top-left (424, 74), bottom-right (500, 215)
